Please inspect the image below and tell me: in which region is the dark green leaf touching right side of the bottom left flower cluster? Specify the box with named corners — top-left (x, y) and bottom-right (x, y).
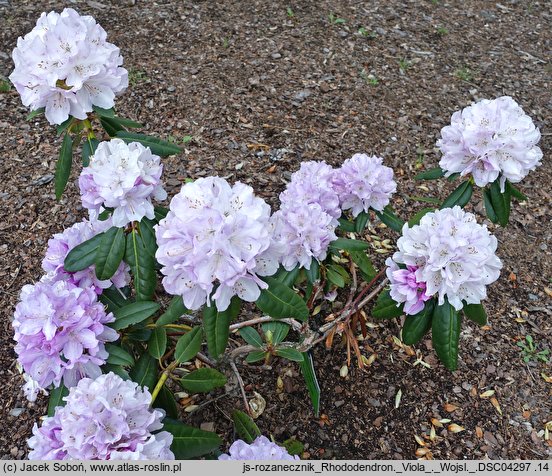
top-left (163, 418), bottom-right (222, 459)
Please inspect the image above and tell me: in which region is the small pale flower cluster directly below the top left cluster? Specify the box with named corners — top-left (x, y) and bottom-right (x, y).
top-left (79, 139), bottom-right (167, 226)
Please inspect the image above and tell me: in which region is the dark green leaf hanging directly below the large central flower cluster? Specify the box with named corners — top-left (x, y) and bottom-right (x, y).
top-left (203, 297), bottom-right (241, 359)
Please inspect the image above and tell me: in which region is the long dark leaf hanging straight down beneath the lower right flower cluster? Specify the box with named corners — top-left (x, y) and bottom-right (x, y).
top-left (431, 298), bottom-right (462, 370)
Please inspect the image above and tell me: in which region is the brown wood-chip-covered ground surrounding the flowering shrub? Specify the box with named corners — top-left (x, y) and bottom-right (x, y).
top-left (0, 0), bottom-right (552, 459)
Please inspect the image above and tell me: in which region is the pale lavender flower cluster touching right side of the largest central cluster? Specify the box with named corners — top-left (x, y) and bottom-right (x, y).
top-left (273, 203), bottom-right (337, 271)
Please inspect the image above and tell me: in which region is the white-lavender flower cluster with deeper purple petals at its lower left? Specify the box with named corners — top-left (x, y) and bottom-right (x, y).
top-left (386, 206), bottom-right (502, 314)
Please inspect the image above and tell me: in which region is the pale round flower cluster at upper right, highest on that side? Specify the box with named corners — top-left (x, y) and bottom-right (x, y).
top-left (437, 96), bottom-right (542, 191)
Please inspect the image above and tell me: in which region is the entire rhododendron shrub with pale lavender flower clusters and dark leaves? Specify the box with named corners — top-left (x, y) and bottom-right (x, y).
top-left (10, 9), bottom-right (542, 460)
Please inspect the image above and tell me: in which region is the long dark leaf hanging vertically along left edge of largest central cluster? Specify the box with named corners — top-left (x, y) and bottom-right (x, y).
top-left (125, 229), bottom-right (157, 301)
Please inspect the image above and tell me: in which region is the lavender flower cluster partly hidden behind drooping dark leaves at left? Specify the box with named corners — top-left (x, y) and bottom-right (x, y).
top-left (42, 218), bottom-right (130, 294)
